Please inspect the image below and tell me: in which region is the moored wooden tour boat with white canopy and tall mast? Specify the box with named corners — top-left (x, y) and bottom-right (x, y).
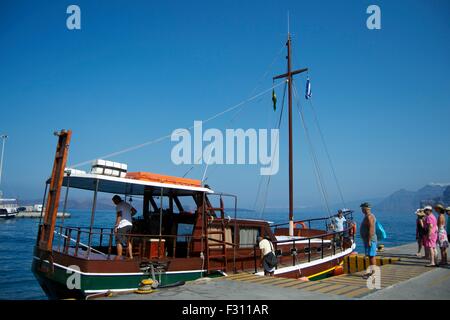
top-left (32, 31), bottom-right (355, 298)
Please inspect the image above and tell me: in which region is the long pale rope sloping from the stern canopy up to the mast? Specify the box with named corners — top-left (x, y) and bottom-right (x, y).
top-left (68, 82), bottom-right (283, 169)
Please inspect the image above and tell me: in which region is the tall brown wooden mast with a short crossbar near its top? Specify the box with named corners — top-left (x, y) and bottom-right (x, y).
top-left (273, 32), bottom-right (308, 236)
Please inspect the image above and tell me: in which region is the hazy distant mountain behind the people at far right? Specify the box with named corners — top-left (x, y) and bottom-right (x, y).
top-left (374, 183), bottom-right (450, 212)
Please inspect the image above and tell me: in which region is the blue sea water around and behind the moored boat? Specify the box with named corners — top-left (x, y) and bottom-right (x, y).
top-left (0, 210), bottom-right (415, 300)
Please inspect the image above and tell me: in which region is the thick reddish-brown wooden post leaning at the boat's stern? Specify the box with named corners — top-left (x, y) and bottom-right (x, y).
top-left (39, 130), bottom-right (72, 251)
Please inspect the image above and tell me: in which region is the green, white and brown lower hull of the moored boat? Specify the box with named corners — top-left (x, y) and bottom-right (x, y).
top-left (32, 242), bottom-right (354, 299)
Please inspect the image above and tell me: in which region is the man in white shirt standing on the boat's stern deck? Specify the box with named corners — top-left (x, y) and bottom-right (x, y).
top-left (112, 195), bottom-right (137, 259)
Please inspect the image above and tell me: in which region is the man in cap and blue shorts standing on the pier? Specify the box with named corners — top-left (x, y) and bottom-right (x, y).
top-left (360, 202), bottom-right (377, 279)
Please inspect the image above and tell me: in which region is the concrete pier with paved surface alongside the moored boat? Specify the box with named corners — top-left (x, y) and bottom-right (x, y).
top-left (96, 243), bottom-right (450, 300)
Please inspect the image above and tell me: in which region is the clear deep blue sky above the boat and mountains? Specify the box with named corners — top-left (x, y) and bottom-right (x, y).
top-left (0, 0), bottom-right (450, 207)
